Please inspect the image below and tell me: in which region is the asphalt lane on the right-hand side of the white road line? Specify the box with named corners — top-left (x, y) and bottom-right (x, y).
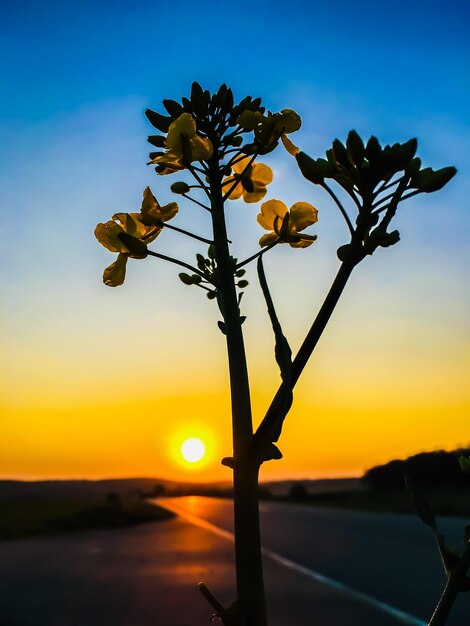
top-left (156, 497), bottom-right (470, 626)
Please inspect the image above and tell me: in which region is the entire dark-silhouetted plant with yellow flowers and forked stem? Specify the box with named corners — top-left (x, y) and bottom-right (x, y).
top-left (95, 83), bottom-right (456, 626)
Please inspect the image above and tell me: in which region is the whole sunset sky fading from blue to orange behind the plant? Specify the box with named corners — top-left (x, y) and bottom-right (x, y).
top-left (0, 0), bottom-right (470, 480)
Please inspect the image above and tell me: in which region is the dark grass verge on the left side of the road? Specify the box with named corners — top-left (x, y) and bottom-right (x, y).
top-left (0, 498), bottom-right (174, 540)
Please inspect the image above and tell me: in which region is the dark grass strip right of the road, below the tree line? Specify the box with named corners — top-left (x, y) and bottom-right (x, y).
top-left (275, 488), bottom-right (470, 518)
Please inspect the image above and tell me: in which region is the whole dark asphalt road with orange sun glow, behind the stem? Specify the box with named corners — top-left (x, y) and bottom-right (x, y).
top-left (0, 497), bottom-right (470, 626)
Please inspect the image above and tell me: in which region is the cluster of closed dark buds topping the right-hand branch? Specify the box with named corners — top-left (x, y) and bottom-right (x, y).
top-left (295, 130), bottom-right (457, 263)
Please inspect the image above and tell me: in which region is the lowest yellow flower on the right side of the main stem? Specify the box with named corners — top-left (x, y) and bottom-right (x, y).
top-left (258, 200), bottom-right (318, 248)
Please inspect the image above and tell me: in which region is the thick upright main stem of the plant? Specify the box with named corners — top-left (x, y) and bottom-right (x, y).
top-left (209, 156), bottom-right (267, 626)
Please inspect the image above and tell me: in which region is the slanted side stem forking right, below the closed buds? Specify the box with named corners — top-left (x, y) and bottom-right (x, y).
top-left (254, 262), bottom-right (355, 449)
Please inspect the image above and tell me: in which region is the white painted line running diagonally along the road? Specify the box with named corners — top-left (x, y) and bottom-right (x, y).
top-left (158, 500), bottom-right (427, 626)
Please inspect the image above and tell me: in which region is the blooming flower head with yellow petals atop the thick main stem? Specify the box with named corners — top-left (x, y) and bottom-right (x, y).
top-left (95, 83), bottom-right (317, 287)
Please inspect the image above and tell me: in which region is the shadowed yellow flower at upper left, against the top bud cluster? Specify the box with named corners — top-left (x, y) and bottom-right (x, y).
top-left (150, 113), bottom-right (213, 174)
